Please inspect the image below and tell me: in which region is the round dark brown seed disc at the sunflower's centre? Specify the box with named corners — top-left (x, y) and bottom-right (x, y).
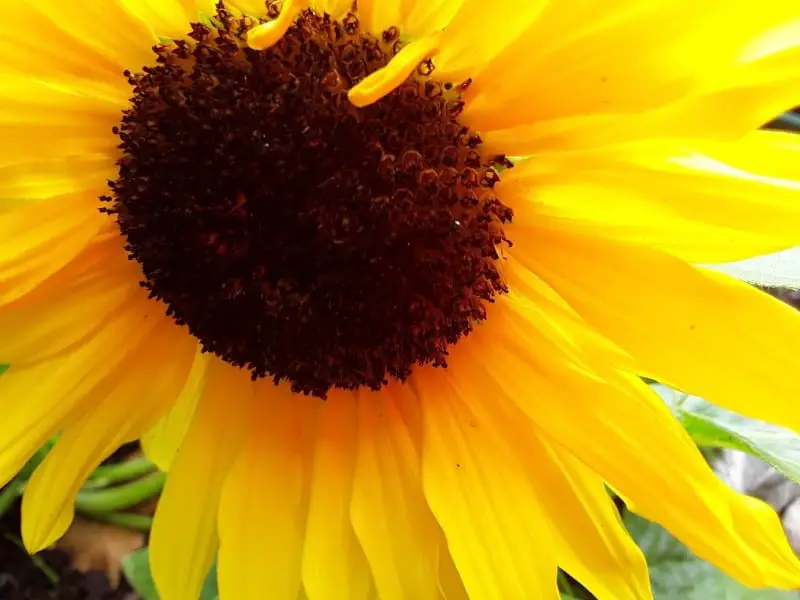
top-left (101, 4), bottom-right (512, 398)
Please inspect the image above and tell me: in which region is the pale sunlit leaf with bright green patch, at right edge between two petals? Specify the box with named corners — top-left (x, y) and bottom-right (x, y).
top-left (651, 384), bottom-right (800, 483)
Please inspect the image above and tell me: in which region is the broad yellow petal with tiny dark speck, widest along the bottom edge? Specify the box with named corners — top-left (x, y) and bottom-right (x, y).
top-left (415, 360), bottom-right (558, 600)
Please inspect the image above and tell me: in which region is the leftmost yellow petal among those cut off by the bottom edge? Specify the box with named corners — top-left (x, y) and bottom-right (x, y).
top-left (150, 360), bottom-right (253, 600)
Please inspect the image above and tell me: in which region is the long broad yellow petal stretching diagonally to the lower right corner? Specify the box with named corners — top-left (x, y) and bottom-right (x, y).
top-left (473, 284), bottom-right (800, 588)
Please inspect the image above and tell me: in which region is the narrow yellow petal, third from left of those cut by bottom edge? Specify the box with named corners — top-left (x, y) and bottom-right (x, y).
top-left (302, 393), bottom-right (373, 600)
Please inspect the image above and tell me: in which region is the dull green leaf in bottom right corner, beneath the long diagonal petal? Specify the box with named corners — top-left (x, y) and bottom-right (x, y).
top-left (624, 513), bottom-right (798, 600)
